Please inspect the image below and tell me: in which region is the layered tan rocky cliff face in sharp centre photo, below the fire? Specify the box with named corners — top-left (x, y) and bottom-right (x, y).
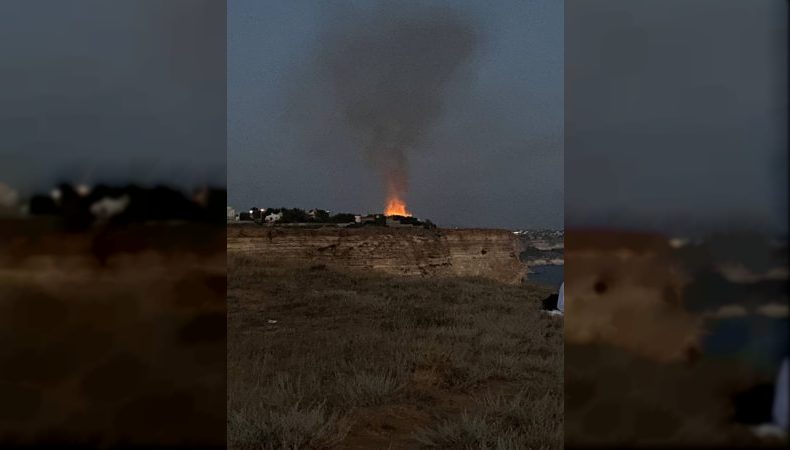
top-left (227, 226), bottom-right (527, 284)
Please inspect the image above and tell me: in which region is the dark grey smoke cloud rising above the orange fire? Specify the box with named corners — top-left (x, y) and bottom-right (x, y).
top-left (317, 4), bottom-right (478, 207)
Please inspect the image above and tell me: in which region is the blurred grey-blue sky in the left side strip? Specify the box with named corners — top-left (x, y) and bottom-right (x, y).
top-left (0, 0), bottom-right (226, 194)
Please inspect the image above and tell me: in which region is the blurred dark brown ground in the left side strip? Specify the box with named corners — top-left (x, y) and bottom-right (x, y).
top-left (0, 220), bottom-right (226, 447)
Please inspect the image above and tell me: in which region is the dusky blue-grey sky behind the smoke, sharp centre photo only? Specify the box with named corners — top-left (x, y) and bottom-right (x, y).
top-left (228, 0), bottom-right (564, 228)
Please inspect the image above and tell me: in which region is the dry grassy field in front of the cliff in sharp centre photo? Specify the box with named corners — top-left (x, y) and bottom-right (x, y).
top-left (228, 254), bottom-right (563, 449)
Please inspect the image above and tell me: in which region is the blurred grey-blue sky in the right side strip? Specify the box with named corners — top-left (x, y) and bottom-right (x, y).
top-left (565, 0), bottom-right (788, 232)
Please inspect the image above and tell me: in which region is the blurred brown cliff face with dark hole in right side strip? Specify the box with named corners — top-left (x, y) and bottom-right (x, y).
top-left (565, 230), bottom-right (700, 362)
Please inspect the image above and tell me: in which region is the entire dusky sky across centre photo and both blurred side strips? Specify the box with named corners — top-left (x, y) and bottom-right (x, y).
top-left (0, 0), bottom-right (788, 234)
